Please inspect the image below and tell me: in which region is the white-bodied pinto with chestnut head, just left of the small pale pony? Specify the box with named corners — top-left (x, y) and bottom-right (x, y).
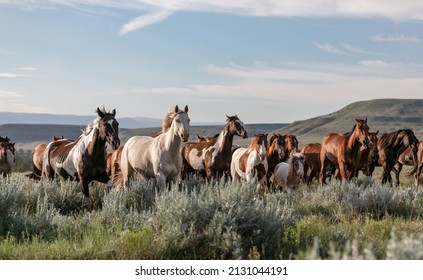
top-left (231, 133), bottom-right (268, 191)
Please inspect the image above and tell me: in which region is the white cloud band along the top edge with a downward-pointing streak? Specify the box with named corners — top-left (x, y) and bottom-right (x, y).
top-left (0, 0), bottom-right (423, 34)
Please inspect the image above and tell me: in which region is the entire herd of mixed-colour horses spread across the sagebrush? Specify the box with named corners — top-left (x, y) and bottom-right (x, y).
top-left (0, 106), bottom-right (423, 199)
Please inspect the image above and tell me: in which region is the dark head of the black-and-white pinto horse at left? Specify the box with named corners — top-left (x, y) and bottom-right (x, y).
top-left (97, 108), bottom-right (120, 150)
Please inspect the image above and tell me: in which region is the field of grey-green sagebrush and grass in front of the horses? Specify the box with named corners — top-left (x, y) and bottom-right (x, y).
top-left (0, 166), bottom-right (423, 260)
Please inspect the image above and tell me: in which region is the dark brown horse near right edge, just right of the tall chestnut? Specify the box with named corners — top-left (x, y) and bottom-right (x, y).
top-left (369, 129), bottom-right (419, 184)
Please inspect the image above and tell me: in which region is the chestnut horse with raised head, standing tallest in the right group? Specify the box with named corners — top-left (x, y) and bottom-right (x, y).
top-left (320, 118), bottom-right (369, 184)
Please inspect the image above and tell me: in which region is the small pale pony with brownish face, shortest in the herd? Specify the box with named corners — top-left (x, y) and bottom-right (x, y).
top-left (273, 153), bottom-right (304, 194)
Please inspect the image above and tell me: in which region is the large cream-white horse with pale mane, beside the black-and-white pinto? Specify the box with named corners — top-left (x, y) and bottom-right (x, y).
top-left (117, 106), bottom-right (190, 190)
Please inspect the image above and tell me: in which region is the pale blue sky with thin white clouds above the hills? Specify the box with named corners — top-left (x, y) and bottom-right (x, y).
top-left (0, 0), bottom-right (423, 123)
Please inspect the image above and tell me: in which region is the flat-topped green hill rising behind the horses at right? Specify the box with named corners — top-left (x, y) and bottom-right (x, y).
top-left (278, 99), bottom-right (423, 147)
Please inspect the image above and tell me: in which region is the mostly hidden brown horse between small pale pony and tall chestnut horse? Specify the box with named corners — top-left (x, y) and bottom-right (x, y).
top-left (300, 143), bottom-right (322, 185)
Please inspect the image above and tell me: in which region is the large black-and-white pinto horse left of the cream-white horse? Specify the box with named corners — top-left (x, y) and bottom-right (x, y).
top-left (42, 108), bottom-right (120, 198)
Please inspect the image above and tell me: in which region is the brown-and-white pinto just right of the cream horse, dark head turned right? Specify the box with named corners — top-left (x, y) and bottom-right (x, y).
top-left (181, 115), bottom-right (247, 179)
